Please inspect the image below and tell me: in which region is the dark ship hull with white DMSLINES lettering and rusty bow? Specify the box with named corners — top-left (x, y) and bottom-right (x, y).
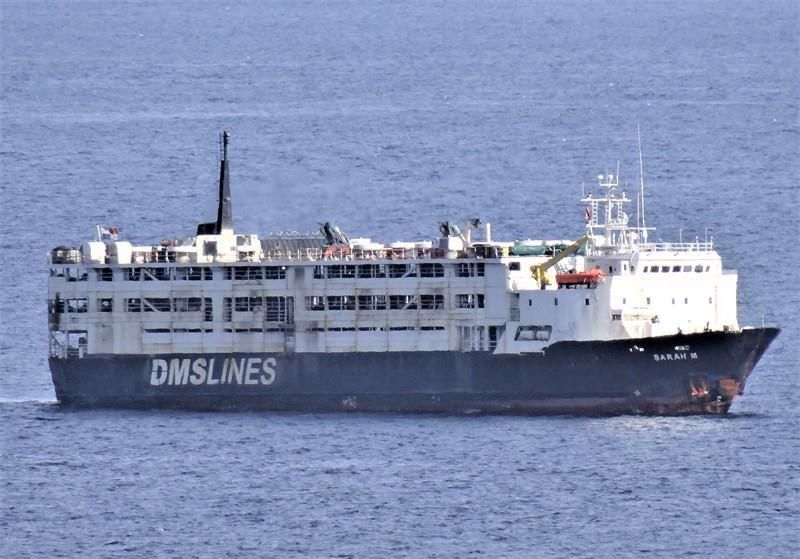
top-left (50, 328), bottom-right (779, 415)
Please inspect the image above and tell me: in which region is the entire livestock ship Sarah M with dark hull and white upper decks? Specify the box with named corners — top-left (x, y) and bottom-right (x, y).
top-left (48, 133), bottom-right (778, 415)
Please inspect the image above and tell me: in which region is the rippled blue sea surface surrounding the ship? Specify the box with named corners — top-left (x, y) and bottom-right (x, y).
top-left (0, 0), bottom-right (800, 558)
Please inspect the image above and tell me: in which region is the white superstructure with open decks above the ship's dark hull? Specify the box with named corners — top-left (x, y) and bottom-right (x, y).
top-left (48, 166), bottom-right (738, 356)
